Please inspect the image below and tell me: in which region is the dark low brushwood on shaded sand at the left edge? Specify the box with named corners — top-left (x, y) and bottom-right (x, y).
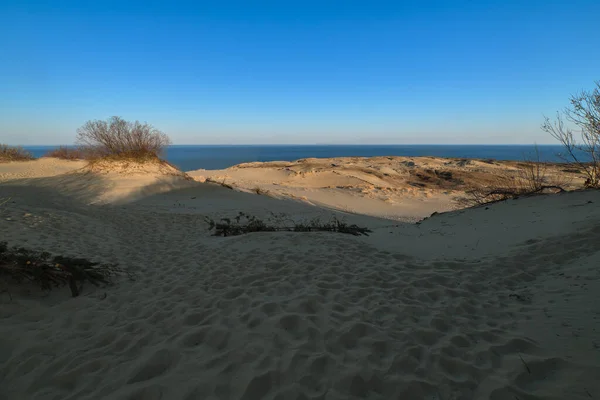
top-left (0, 242), bottom-right (133, 297)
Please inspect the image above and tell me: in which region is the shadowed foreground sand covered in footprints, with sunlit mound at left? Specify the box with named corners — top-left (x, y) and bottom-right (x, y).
top-left (0, 160), bottom-right (600, 400)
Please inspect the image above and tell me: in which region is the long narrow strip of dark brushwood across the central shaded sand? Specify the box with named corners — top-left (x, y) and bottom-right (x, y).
top-left (206, 212), bottom-right (372, 236)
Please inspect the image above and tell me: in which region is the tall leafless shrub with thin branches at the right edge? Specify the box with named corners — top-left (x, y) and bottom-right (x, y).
top-left (542, 81), bottom-right (600, 188)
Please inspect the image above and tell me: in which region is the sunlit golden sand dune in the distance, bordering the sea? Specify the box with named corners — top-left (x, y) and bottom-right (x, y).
top-left (188, 157), bottom-right (583, 222)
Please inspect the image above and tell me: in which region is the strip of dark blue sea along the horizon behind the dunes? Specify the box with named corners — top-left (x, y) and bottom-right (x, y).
top-left (24, 145), bottom-right (564, 171)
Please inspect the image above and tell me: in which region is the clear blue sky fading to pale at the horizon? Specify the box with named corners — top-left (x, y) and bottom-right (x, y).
top-left (0, 0), bottom-right (600, 145)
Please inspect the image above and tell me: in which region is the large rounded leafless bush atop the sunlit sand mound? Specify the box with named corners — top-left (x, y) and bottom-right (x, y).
top-left (77, 117), bottom-right (171, 161)
